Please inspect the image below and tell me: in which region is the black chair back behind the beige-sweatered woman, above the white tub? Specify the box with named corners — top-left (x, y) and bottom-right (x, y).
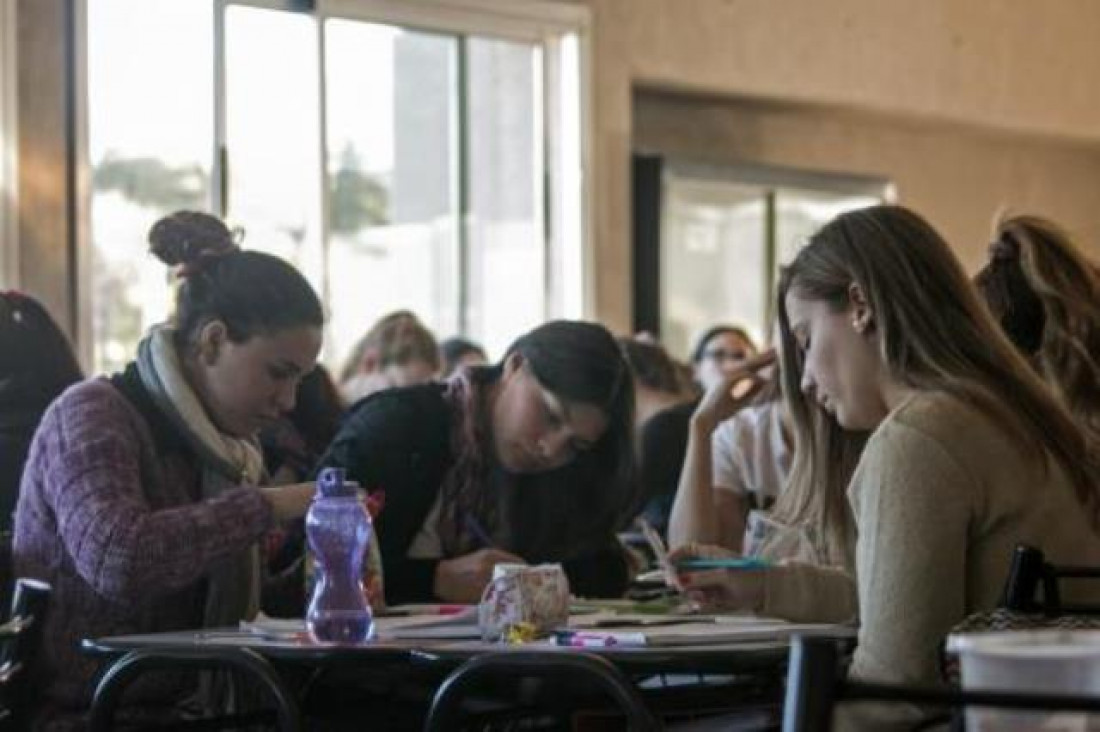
top-left (1001, 544), bottom-right (1100, 615)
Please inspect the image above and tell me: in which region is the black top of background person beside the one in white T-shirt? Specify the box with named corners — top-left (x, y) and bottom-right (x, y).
top-left (638, 400), bottom-right (699, 536)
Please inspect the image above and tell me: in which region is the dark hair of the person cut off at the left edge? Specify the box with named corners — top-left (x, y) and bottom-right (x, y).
top-left (0, 292), bottom-right (84, 422)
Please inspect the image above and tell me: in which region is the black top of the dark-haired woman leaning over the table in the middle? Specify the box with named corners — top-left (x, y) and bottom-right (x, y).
top-left (319, 384), bottom-right (628, 604)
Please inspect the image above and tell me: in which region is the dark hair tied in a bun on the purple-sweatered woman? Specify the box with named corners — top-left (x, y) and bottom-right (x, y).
top-left (149, 211), bottom-right (325, 347)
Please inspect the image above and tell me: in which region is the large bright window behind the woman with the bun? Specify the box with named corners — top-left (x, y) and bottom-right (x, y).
top-left (81, 0), bottom-right (587, 371)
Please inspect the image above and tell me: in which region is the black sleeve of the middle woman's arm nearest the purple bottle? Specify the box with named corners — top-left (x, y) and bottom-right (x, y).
top-left (319, 384), bottom-right (450, 604)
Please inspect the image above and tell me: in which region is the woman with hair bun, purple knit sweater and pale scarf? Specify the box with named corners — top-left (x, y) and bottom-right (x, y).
top-left (13, 211), bottom-right (323, 729)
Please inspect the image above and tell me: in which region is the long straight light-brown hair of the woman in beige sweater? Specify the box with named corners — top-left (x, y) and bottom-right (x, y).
top-left (778, 206), bottom-right (1100, 536)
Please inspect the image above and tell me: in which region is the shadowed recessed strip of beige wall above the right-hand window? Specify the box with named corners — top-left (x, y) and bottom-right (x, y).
top-left (633, 91), bottom-right (1100, 270)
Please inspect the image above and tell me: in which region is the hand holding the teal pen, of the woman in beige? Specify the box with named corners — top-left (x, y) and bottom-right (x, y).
top-left (669, 544), bottom-right (767, 612)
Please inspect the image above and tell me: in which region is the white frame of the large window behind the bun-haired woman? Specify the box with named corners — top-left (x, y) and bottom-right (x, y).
top-left (74, 0), bottom-right (595, 365)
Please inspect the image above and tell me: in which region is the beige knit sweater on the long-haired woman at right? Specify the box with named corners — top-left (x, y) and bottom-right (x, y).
top-left (763, 393), bottom-right (1100, 729)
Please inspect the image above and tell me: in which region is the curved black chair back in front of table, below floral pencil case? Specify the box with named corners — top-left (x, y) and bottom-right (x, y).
top-left (425, 651), bottom-right (661, 732)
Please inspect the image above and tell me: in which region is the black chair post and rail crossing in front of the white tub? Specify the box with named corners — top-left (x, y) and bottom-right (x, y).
top-left (782, 636), bottom-right (1100, 732)
